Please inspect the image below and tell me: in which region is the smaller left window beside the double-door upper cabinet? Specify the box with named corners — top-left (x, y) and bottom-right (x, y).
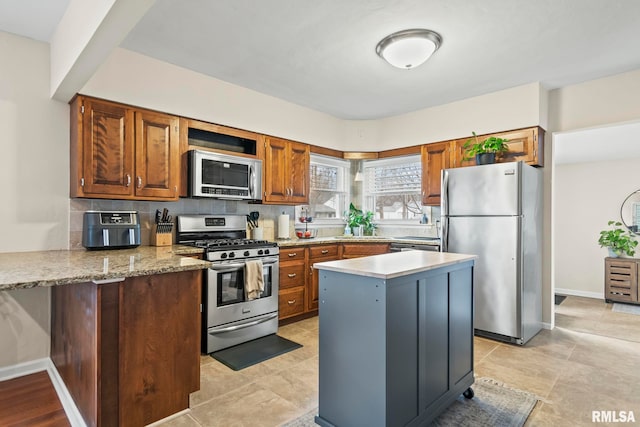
top-left (296, 154), bottom-right (350, 222)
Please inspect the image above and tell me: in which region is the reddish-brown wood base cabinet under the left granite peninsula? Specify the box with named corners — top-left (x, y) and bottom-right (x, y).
top-left (51, 270), bottom-right (202, 426)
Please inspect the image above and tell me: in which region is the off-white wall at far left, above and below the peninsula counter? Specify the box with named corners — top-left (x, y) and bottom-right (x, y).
top-left (0, 32), bottom-right (69, 366)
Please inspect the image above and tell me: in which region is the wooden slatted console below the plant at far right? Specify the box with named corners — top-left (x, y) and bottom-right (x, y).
top-left (604, 257), bottom-right (640, 304)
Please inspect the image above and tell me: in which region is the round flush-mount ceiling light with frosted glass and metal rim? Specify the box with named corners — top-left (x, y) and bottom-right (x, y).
top-left (376, 29), bottom-right (442, 70)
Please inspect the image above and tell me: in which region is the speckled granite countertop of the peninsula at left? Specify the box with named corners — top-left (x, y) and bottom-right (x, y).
top-left (0, 246), bottom-right (211, 290)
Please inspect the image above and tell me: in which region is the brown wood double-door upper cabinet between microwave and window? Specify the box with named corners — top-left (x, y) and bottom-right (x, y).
top-left (262, 136), bottom-right (310, 204)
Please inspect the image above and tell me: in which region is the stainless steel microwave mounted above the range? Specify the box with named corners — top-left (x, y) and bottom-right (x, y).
top-left (189, 150), bottom-right (262, 200)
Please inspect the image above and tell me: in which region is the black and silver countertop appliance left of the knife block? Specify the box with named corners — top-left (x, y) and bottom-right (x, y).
top-left (82, 211), bottom-right (140, 249)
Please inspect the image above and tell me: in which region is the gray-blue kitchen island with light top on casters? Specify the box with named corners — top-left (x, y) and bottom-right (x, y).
top-left (314, 251), bottom-right (476, 427)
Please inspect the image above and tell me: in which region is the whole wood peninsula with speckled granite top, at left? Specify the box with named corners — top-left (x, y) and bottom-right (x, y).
top-left (0, 247), bottom-right (209, 426)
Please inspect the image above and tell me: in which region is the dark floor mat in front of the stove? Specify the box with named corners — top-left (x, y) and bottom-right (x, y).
top-left (211, 334), bottom-right (302, 371)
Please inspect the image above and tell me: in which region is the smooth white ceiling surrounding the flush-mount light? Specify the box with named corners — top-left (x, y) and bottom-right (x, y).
top-left (0, 0), bottom-right (640, 119)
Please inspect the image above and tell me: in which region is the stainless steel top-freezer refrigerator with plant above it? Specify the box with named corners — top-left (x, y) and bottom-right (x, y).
top-left (441, 162), bottom-right (542, 345)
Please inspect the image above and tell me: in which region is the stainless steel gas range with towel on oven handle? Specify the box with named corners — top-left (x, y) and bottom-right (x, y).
top-left (176, 215), bottom-right (279, 353)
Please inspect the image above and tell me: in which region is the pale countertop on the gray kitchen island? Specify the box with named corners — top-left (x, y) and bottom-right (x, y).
top-left (313, 251), bottom-right (477, 279)
